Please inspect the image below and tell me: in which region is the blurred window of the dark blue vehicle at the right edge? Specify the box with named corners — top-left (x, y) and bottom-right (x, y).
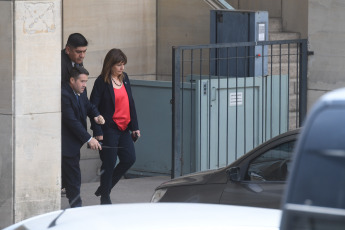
top-left (289, 107), bottom-right (345, 209)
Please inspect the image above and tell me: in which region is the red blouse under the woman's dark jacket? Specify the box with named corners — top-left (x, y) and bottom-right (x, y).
top-left (113, 85), bottom-right (131, 131)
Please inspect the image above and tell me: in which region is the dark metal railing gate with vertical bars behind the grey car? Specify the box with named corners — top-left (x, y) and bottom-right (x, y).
top-left (171, 39), bottom-right (308, 178)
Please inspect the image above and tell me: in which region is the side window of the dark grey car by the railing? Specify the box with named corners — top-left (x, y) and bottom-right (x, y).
top-left (245, 141), bottom-right (295, 181)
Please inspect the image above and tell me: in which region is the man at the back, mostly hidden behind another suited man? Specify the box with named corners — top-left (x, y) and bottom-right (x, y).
top-left (61, 33), bottom-right (88, 82)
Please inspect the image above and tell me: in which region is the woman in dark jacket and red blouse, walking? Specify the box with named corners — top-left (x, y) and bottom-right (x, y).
top-left (90, 49), bottom-right (140, 204)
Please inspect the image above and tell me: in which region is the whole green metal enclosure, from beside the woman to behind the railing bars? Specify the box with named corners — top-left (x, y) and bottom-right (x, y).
top-left (129, 75), bottom-right (288, 176)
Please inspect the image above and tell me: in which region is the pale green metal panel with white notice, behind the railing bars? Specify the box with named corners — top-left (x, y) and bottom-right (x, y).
top-left (195, 76), bottom-right (288, 171)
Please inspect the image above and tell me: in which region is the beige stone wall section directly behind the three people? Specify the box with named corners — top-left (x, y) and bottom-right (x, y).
top-left (61, 0), bottom-right (156, 183)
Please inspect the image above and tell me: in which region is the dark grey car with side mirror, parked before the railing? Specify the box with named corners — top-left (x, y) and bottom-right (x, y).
top-left (151, 129), bottom-right (299, 209)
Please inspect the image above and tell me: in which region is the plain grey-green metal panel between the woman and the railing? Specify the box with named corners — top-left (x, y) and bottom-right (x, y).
top-left (130, 80), bottom-right (172, 176)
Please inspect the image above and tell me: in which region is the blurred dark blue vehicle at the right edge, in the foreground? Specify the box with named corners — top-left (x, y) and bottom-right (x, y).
top-left (280, 88), bottom-right (345, 230)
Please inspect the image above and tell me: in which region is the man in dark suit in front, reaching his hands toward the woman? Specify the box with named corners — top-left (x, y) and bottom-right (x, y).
top-left (61, 66), bottom-right (104, 208)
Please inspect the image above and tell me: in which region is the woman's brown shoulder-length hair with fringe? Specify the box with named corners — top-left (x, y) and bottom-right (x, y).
top-left (101, 48), bottom-right (127, 84)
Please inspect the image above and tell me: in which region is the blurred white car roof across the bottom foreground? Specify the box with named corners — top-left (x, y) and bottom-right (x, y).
top-left (4, 203), bottom-right (281, 230)
